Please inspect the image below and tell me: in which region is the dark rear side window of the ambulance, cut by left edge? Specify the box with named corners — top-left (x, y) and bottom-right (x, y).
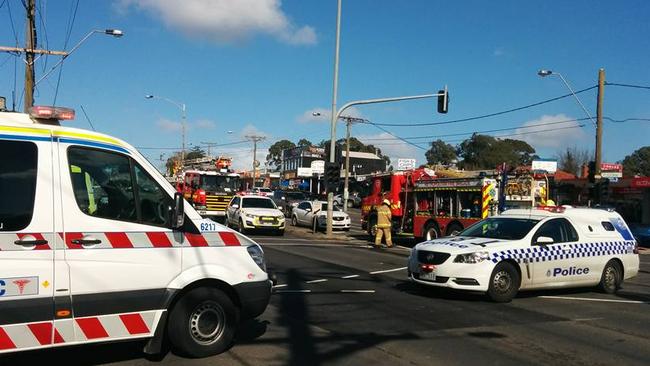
top-left (0, 141), bottom-right (38, 231)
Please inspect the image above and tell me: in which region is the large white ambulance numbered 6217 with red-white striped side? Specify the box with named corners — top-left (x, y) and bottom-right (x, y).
top-left (0, 107), bottom-right (272, 357)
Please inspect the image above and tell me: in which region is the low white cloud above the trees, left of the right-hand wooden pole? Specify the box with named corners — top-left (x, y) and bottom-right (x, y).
top-left (513, 114), bottom-right (587, 149)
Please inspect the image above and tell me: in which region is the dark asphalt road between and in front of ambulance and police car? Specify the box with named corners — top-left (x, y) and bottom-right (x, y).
top-left (0, 216), bottom-right (650, 365)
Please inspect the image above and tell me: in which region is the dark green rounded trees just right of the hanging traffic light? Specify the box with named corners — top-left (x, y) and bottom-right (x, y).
top-left (457, 134), bottom-right (537, 169)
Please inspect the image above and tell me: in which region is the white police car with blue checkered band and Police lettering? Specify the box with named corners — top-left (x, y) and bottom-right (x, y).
top-left (408, 207), bottom-right (639, 302)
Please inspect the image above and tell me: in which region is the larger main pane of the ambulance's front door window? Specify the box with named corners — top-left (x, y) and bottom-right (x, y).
top-left (68, 147), bottom-right (138, 221)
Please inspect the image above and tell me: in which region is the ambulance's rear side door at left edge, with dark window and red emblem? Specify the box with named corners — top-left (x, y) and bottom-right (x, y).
top-left (0, 137), bottom-right (57, 352)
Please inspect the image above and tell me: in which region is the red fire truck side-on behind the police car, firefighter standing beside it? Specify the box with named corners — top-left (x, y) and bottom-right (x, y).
top-left (361, 168), bottom-right (498, 240)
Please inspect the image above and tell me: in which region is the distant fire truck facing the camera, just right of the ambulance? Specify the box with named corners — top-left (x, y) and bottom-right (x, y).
top-left (176, 157), bottom-right (241, 220)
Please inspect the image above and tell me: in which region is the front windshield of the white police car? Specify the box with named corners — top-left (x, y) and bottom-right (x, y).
top-left (458, 217), bottom-right (539, 240)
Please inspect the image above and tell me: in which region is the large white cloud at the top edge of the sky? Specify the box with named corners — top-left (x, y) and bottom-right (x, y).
top-left (116, 0), bottom-right (317, 45)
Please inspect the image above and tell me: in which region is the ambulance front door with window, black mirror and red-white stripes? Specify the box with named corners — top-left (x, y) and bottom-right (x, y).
top-left (59, 141), bottom-right (181, 342)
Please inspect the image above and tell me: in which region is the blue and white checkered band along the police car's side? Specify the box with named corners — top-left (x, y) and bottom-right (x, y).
top-left (491, 240), bottom-right (635, 263)
